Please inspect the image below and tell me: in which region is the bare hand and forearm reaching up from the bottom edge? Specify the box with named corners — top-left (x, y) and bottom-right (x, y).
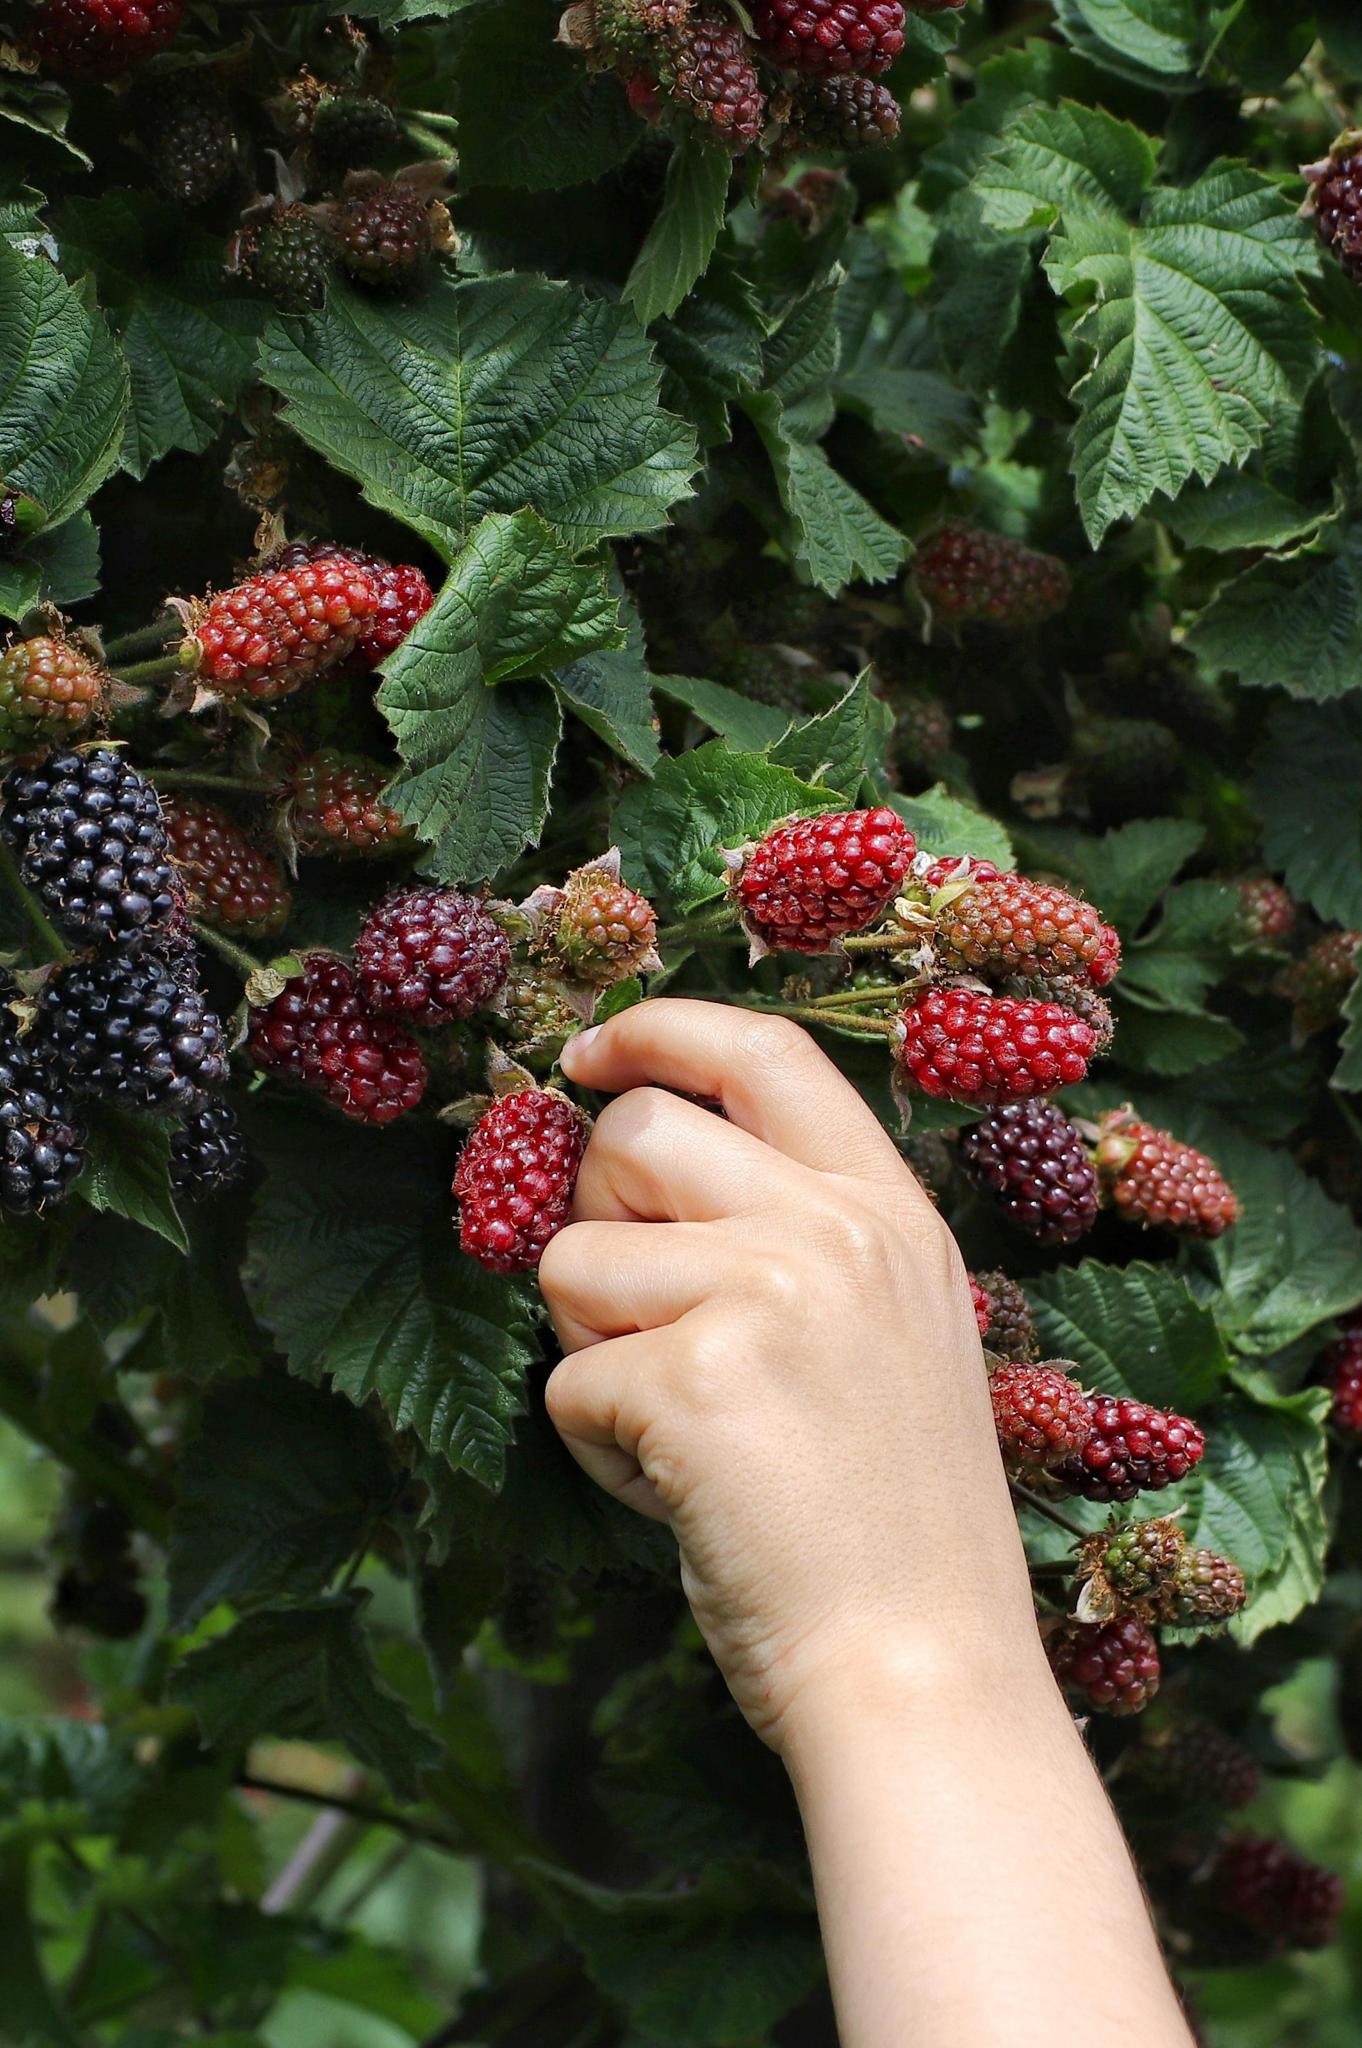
top-left (541, 999), bottom-right (1190, 2048)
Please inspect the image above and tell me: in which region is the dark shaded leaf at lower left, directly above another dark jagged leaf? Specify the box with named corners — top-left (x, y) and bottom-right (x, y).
top-left (168, 1376), bottom-right (393, 1630)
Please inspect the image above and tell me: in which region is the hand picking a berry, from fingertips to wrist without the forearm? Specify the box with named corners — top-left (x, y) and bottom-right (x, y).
top-left (539, 999), bottom-right (1053, 1749)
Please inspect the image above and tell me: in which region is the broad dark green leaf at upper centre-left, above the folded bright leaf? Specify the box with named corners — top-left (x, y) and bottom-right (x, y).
top-left (260, 276), bottom-right (694, 559)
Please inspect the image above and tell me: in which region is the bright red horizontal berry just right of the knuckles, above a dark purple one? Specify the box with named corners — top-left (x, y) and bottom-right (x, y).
top-left (899, 989), bottom-right (1098, 1106)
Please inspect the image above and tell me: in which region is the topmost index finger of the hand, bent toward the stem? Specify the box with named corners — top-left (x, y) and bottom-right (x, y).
top-left (563, 995), bottom-right (905, 1186)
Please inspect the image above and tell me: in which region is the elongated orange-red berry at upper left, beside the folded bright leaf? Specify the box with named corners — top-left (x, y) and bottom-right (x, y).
top-left (184, 555), bottom-right (379, 705)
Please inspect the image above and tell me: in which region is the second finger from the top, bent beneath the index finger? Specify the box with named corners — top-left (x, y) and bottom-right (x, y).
top-left (571, 1087), bottom-right (799, 1223)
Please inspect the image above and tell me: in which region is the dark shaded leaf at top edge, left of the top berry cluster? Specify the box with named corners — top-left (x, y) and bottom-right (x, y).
top-left (448, 0), bottom-right (639, 193)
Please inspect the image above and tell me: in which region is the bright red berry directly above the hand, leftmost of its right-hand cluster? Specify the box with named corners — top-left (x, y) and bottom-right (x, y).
top-left (733, 809), bottom-right (918, 952)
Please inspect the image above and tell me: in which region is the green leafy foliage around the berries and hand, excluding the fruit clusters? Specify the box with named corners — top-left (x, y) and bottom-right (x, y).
top-left (0, 0), bottom-right (1362, 2048)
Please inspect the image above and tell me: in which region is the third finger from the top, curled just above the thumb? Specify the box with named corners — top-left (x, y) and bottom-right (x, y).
top-left (539, 1223), bottom-right (733, 1352)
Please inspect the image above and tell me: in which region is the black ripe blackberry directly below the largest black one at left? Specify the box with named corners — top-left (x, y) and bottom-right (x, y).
top-left (39, 952), bottom-right (227, 1118)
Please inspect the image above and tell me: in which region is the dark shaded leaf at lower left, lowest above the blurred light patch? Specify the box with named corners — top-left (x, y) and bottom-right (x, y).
top-left (168, 1595), bottom-right (442, 1800)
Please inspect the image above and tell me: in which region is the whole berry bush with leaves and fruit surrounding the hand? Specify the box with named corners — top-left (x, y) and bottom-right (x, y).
top-left (0, 0), bottom-right (1362, 2048)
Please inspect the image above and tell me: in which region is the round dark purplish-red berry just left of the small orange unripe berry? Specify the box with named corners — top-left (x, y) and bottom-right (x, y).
top-left (354, 889), bottom-right (510, 1028)
